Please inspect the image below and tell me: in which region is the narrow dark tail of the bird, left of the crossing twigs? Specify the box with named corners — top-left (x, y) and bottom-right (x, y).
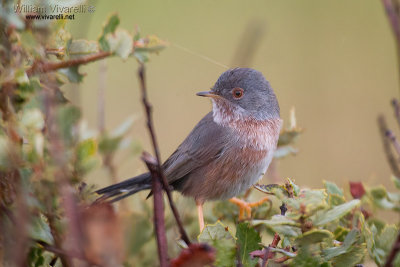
top-left (96, 173), bottom-right (151, 202)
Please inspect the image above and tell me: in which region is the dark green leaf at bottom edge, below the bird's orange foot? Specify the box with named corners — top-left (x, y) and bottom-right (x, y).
top-left (236, 223), bottom-right (261, 266)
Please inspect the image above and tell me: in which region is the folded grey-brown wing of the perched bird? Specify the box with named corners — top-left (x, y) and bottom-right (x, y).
top-left (163, 112), bottom-right (229, 184)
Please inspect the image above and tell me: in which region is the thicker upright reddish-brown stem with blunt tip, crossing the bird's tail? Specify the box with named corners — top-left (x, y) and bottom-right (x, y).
top-left (142, 152), bottom-right (169, 267)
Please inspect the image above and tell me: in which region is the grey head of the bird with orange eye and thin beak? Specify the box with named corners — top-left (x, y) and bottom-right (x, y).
top-left (197, 68), bottom-right (280, 120)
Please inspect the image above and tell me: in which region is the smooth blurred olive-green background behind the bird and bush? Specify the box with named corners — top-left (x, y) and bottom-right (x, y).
top-left (64, 0), bottom-right (399, 205)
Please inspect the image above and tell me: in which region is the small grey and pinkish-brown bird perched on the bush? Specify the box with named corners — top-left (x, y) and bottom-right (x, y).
top-left (96, 68), bottom-right (282, 230)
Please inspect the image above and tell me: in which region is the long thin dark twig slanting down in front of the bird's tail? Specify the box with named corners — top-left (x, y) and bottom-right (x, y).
top-left (138, 64), bottom-right (191, 245)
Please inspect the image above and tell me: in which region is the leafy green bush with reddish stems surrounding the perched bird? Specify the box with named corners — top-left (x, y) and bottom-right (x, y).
top-left (0, 1), bottom-right (400, 266)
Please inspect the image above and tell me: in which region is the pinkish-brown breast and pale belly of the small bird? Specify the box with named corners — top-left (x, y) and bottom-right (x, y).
top-left (189, 119), bottom-right (282, 200)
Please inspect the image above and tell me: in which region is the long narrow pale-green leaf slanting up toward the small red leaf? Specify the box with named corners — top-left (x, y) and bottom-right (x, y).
top-left (313, 199), bottom-right (360, 226)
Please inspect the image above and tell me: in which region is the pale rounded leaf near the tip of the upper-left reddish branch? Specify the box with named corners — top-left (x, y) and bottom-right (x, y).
top-left (106, 30), bottom-right (133, 59)
